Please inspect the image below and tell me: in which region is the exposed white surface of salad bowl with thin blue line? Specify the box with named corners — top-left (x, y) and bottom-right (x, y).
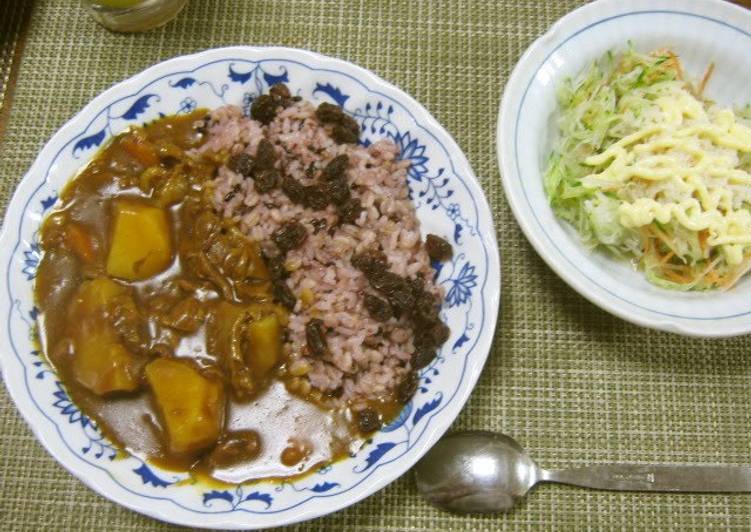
top-left (496, 0), bottom-right (751, 337)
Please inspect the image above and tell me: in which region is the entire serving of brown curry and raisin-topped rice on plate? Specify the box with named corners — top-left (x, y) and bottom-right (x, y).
top-left (35, 85), bottom-right (452, 482)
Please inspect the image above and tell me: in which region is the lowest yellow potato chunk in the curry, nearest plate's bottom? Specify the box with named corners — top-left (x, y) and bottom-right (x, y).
top-left (146, 358), bottom-right (224, 454)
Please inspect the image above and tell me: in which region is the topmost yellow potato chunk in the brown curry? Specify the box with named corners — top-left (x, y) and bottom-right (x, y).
top-left (107, 198), bottom-right (172, 281)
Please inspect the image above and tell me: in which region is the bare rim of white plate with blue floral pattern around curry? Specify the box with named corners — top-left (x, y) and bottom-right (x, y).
top-left (0, 47), bottom-right (500, 529)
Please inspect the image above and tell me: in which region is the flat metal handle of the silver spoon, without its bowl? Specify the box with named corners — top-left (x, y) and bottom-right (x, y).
top-left (540, 464), bottom-right (751, 493)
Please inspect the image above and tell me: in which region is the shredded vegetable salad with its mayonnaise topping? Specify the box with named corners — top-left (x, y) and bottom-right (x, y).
top-left (544, 49), bottom-right (751, 290)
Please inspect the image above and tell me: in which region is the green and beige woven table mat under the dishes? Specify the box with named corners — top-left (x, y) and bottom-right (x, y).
top-left (0, 0), bottom-right (751, 531)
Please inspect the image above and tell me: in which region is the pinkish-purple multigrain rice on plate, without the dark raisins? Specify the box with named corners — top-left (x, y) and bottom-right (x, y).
top-left (201, 101), bottom-right (441, 404)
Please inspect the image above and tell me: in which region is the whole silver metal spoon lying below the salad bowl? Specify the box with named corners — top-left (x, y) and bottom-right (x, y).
top-left (415, 431), bottom-right (751, 513)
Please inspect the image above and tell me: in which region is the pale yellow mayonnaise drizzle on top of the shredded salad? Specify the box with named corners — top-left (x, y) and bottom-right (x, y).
top-left (582, 81), bottom-right (751, 265)
